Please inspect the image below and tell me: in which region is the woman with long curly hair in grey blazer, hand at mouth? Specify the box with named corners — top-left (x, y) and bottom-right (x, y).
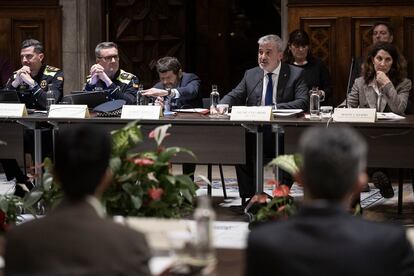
top-left (348, 42), bottom-right (411, 114)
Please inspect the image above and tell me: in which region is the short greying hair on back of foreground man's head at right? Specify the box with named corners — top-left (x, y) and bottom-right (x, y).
top-left (300, 126), bottom-right (367, 201)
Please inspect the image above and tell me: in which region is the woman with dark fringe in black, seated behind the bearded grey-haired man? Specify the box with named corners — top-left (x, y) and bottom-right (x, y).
top-left (283, 30), bottom-right (331, 102)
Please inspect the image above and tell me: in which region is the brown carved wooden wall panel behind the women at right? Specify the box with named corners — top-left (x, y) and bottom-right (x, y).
top-left (288, 3), bottom-right (414, 105)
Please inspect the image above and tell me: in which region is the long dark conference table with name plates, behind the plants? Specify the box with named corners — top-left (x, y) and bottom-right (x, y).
top-left (0, 113), bottom-right (414, 210)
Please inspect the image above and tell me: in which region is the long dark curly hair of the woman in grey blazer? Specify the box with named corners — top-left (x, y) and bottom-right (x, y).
top-left (362, 42), bottom-right (407, 86)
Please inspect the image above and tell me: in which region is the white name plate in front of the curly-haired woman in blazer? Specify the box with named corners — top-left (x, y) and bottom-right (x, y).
top-left (332, 108), bottom-right (376, 123)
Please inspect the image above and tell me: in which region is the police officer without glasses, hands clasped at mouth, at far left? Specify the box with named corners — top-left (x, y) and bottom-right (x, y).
top-left (6, 39), bottom-right (63, 110)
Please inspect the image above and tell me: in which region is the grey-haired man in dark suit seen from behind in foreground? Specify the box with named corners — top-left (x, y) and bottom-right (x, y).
top-left (246, 126), bottom-right (414, 276)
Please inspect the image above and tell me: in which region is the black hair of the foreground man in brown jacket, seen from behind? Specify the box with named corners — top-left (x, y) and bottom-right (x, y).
top-left (54, 124), bottom-right (112, 200)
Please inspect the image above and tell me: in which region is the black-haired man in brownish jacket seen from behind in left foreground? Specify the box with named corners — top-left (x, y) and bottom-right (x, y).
top-left (5, 125), bottom-right (150, 275)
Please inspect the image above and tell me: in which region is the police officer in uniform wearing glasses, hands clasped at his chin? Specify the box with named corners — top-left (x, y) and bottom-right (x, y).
top-left (84, 42), bottom-right (139, 104)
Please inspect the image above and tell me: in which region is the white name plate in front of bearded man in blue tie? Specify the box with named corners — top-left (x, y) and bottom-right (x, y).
top-left (230, 106), bottom-right (273, 121)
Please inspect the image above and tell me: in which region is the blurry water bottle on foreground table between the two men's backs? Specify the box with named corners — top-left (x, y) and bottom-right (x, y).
top-left (194, 196), bottom-right (216, 266)
